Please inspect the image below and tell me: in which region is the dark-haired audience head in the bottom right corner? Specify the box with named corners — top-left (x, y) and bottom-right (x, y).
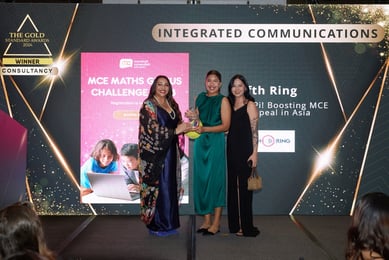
top-left (346, 192), bottom-right (389, 260)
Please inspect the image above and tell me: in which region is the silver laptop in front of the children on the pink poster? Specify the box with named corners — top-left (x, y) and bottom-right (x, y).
top-left (87, 172), bottom-right (139, 200)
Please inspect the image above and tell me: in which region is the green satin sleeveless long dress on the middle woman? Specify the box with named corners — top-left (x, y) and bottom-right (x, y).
top-left (193, 92), bottom-right (226, 215)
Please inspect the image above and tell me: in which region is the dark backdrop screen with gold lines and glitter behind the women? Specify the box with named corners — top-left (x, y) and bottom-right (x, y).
top-left (0, 4), bottom-right (389, 215)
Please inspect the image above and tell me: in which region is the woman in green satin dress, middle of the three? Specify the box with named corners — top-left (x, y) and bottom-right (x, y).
top-left (186, 70), bottom-right (231, 235)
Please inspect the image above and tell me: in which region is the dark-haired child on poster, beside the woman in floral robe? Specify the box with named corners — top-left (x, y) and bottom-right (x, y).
top-left (120, 143), bottom-right (140, 200)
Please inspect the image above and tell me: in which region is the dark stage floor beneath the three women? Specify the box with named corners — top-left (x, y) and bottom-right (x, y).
top-left (41, 216), bottom-right (350, 260)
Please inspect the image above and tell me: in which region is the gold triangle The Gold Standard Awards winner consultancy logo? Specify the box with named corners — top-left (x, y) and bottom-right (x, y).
top-left (1, 14), bottom-right (58, 76)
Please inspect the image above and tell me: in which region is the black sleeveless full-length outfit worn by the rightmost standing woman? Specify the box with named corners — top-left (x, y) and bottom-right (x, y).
top-left (227, 104), bottom-right (259, 236)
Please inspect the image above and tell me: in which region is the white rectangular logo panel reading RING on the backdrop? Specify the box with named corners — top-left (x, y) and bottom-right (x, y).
top-left (258, 130), bottom-right (295, 153)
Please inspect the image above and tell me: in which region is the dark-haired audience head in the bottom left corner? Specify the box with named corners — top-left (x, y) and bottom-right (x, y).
top-left (0, 202), bottom-right (55, 259)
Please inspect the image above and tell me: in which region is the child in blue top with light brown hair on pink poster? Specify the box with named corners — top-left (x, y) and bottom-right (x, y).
top-left (80, 139), bottom-right (119, 196)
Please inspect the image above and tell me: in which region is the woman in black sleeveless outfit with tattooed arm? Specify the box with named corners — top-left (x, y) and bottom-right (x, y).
top-left (227, 74), bottom-right (259, 237)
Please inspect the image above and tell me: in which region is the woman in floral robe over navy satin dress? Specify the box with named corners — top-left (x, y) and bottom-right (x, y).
top-left (139, 76), bottom-right (192, 236)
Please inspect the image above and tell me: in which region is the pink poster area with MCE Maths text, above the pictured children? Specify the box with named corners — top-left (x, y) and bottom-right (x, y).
top-left (81, 53), bottom-right (189, 164)
